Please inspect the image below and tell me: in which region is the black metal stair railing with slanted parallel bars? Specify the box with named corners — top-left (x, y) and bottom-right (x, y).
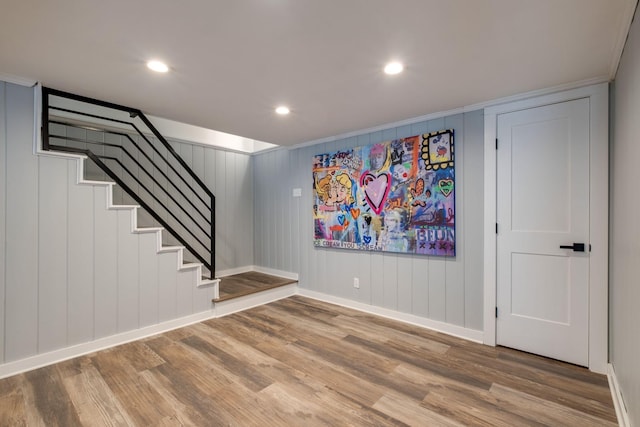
top-left (42, 88), bottom-right (215, 277)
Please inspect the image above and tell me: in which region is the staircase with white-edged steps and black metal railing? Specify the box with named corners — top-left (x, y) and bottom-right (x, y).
top-left (42, 88), bottom-right (219, 299)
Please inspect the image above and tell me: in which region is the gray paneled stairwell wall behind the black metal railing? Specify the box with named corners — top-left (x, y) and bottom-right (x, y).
top-left (52, 120), bottom-right (253, 271)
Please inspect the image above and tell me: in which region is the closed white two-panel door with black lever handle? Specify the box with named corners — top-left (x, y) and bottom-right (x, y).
top-left (496, 98), bottom-right (592, 366)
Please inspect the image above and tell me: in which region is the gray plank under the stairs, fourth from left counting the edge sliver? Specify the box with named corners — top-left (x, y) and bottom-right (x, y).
top-left (65, 166), bottom-right (95, 345)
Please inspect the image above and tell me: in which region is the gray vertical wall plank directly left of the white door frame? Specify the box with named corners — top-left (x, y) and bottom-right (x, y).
top-left (457, 110), bottom-right (484, 330)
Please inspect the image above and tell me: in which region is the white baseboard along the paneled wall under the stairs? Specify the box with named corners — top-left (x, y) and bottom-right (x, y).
top-left (0, 310), bottom-right (215, 379)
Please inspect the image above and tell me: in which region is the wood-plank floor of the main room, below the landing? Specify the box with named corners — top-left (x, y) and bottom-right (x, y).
top-left (0, 296), bottom-right (616, 426)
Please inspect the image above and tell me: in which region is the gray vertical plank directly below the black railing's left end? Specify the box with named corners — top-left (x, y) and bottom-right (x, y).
top-left (37, 156), bottom-right (69, 352)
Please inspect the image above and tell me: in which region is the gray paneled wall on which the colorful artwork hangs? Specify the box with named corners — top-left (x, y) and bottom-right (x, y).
top-left (253, 110), bottom-right (484, 330)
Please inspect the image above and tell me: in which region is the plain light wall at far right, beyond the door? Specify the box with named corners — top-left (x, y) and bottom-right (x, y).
top-left (609, 9), bottom-right (640, 425)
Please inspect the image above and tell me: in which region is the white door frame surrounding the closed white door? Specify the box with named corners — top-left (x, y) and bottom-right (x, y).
top-left (483, 83), bottom-right (609, 374)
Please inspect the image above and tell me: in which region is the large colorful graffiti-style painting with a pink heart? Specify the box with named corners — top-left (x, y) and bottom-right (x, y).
top-left (313, 129), bottom-right (456, 256)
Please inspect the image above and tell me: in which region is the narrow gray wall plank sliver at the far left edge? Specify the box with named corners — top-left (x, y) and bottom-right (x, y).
top-left (0, 81), bottom-right (7, 363)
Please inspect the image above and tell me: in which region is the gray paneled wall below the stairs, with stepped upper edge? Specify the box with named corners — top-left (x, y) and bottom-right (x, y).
top-left (0, 82), bottom-right (220, 364)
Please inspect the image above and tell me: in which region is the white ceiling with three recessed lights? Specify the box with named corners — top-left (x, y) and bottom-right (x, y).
top-left (0, 0), bottom-right (637, 145)
